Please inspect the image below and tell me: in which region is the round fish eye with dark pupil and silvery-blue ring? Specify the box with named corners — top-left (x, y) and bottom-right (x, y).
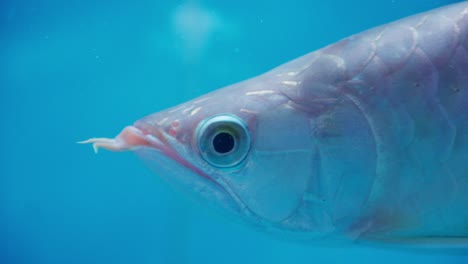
top-left (195, 115), bottom-right (250, 168)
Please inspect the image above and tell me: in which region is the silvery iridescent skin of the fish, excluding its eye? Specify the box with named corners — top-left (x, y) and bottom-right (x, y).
top-left (85, 2), bottom-right (468, 245)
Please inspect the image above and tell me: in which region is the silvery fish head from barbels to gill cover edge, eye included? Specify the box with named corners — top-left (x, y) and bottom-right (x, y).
top-left (86, 73), bottom-right (326, 235)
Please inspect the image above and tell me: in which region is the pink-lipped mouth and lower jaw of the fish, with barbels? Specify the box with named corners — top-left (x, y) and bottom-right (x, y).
top-left (78, 125), bottom-right (251, 220)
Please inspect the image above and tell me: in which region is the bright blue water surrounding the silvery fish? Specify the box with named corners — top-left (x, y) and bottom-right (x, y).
top-left (0, 0), bottom-right (468, 264)
